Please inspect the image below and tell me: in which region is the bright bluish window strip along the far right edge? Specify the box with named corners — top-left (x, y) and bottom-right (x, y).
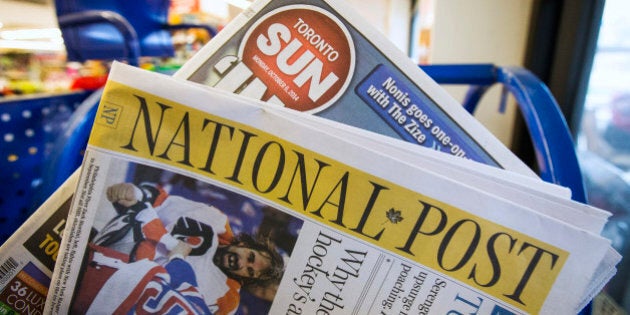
top-left (577, 0), bottom-right (630, 311)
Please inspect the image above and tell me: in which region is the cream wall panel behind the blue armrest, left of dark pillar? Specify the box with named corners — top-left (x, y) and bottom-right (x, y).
top-left (432, 0), bottom-right (534, 147)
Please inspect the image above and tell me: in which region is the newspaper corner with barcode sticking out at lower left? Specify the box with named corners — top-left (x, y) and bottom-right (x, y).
top-left (0, 172), bottom-right (79, 314)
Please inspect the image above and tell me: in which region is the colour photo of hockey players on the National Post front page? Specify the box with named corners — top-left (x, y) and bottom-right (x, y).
top-left (72, 165), bottom-right (302, 314)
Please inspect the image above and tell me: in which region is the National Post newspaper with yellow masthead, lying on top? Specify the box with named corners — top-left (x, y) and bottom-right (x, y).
top-left (45, 63), bottom-right (619, 314)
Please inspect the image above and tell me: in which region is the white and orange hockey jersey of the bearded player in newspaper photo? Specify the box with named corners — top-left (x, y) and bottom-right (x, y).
top-left (89, 191), bottom-right (240, 314)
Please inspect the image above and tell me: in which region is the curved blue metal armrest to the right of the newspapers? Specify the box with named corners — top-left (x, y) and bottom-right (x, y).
top-left (420, 64), bottom-right (586, 203)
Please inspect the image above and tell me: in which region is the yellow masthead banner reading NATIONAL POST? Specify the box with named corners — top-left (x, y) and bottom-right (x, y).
top-left (90, 80), bottom-right (568, 313)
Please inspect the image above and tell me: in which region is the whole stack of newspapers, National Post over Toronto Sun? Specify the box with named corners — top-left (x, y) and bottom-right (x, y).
top-left (0, 0), bottom-right (621, 314)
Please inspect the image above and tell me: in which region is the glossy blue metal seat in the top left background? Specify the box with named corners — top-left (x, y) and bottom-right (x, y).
top-left (55, 0), bottom-right (216, 66)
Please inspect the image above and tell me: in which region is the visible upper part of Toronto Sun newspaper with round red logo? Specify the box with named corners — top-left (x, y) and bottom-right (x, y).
top-left (175, 0), bottom-right (536, 176)
